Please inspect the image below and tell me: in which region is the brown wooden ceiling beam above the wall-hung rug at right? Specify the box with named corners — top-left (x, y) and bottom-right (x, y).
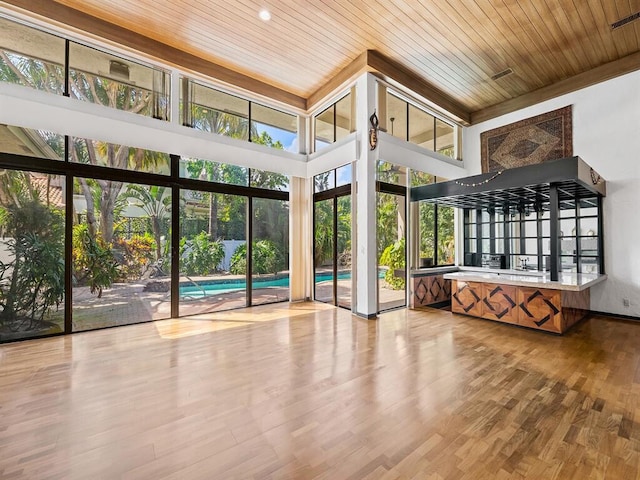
top-left (471, 52), bottom-right (640, 124)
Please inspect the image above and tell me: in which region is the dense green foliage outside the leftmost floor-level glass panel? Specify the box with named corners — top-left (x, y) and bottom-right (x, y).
top-left (0, 199), bottom-right (64, 326)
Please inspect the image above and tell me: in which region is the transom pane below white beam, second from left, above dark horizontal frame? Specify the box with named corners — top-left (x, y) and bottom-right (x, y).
top-left (69, 137), bottom-right (171, 175)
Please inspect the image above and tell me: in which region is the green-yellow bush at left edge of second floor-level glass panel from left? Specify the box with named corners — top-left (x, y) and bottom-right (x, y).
top-left (73, 224), bottom-right (119, 298)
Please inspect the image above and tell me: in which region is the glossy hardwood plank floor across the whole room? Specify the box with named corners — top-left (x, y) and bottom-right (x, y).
top-left (0, 303), bottom-right (640, 480)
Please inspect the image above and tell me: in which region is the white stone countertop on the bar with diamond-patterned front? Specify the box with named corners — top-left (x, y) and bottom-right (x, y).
top-left (444, 270), bottom-right (607, 292)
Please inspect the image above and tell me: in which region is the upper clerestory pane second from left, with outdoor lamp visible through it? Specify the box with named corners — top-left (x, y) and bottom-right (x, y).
top-left (69, 43), bottom-right (171, 120)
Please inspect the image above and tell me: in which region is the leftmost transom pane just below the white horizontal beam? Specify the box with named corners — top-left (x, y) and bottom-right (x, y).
top-left (0, 124), bottom-right (64, 160)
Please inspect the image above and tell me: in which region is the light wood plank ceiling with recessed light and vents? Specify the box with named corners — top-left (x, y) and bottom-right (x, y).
top-left (0, 0), bottom-right (640, 119)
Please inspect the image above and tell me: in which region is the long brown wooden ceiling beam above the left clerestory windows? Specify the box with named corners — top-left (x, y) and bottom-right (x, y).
top-left (4, 0), bottom-right (307, 110)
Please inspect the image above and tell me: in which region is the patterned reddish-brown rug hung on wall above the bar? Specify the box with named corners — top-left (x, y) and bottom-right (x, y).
top-left (480, 105), bottom-right (573, 173)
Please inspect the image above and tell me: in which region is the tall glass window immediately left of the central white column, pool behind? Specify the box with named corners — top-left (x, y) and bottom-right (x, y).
top-left (313, 165), bottom-right (352, 308)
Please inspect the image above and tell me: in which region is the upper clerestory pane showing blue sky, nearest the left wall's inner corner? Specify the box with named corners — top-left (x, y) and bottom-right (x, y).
top-left (251, 103), bottom-right (299, 153)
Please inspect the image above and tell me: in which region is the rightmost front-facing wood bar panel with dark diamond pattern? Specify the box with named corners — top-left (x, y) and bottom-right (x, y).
top-left (518, 287), bottom-right (562, 333)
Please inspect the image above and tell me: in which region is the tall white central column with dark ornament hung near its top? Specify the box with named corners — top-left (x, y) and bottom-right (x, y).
top-left (352, 73), bottom-right (378, 318)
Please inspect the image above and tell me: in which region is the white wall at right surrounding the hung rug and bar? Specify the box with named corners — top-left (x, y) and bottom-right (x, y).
top-left (463, 71), bottom-right (640, 317)
